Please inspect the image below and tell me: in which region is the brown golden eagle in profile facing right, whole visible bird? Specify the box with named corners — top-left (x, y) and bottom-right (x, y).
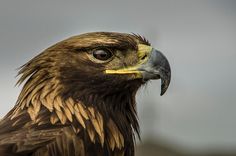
top-left (0, 32), bottom-right (171, 156)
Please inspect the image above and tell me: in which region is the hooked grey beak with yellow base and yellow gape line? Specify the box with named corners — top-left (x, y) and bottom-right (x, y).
top-left (105, 44), bottom-right (171, 95)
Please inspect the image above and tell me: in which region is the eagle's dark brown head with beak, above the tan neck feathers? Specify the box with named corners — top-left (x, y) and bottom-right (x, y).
top-left (20, 32), bottom-right (171, 95)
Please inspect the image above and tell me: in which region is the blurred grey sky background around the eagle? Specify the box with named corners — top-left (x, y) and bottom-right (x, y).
top-left (0, 0), bottom-right (236, 156)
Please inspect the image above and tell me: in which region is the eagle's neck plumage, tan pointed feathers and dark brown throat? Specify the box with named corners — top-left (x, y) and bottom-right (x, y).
top-left (10, 75), bottom-right (139, 150)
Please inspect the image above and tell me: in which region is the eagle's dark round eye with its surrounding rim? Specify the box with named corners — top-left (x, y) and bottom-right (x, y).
top-left (91, 49), bottom-right (113, 62)
